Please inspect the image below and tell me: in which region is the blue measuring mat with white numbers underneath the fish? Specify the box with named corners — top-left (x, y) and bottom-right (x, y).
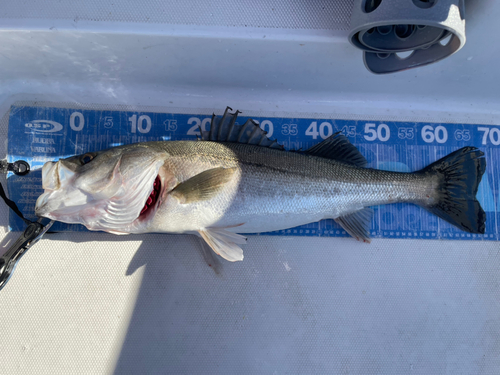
top-left (4, 106), bottom-right (500, 240)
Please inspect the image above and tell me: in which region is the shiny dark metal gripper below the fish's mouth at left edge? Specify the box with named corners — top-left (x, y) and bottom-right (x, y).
top-left (0, 218), bottom-right (54, 290)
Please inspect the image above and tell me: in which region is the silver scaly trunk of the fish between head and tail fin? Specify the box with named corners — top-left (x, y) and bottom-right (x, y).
top-left (148, 142), bottom-right (436, 233)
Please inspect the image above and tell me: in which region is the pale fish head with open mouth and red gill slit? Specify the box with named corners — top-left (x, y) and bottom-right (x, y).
top-left (35, 144), bottom-right (168, 233)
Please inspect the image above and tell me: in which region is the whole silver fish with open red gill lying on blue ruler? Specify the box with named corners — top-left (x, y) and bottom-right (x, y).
top-left (35, 107), bottom-right (486, 261)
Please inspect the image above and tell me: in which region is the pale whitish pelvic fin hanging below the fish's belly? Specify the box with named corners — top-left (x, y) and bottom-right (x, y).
top-left (198, 228), bottom-right (247, 262)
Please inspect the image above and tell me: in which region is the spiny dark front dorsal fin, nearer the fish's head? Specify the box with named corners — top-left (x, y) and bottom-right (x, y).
top-left (201, 107), bottom-right (283, 150)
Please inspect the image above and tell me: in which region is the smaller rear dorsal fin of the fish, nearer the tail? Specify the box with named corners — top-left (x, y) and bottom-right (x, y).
top-left (303, 132), bottom-right (368, 167)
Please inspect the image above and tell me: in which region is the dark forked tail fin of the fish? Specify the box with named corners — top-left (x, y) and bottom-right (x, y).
top-left (420, 147), bottom-right (486, 233)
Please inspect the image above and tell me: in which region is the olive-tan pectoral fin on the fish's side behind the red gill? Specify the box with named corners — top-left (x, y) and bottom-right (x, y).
top-left (170, 168), bottom-right (236, 204)
